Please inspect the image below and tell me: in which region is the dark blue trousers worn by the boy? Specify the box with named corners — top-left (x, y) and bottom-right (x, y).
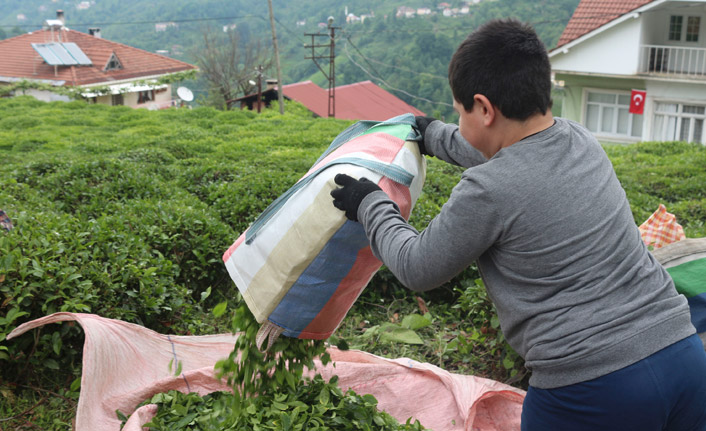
top-left (522, 335), bottom-right (706, 431)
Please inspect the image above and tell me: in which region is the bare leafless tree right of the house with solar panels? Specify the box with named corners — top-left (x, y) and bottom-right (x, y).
top-left (193, 29), bottom-right (272, 107)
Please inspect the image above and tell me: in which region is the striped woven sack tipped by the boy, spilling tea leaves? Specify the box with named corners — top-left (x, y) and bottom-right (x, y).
top-left (223, 114), bottom-right (426, 348)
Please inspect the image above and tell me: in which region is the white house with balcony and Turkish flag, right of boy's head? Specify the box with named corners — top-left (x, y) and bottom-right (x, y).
top-left (549, 0), bottom-right (706, 144)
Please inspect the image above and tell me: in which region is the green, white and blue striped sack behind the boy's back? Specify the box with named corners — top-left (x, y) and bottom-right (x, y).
top-left (652, 238), bottom-right (706, 345)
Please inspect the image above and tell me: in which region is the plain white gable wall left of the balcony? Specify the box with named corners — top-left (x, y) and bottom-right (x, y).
top-left (550, 18), bottom-right (642, 75)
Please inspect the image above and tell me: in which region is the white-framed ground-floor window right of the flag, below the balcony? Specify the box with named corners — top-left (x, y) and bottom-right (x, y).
top-left (652, 102), bottom-right (706, 144)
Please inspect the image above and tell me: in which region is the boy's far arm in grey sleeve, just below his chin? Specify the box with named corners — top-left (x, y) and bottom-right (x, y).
top-left (424, 120), bottom-right (487, 168)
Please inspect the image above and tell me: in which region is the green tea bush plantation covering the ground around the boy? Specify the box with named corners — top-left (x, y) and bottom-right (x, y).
top-left (0, 97), bottom-right (706, 430)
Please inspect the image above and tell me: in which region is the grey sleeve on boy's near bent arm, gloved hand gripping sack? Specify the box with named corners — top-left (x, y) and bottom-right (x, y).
top-left (358, 171), bottom-right (502, 291)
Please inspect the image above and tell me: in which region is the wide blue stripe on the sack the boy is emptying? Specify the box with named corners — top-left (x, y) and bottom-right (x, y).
top-left (268, 220), bottom-right (368, 338)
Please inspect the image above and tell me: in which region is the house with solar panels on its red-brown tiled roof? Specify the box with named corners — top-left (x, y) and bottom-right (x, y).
top-left (0, 15), bottom-right (196, 109)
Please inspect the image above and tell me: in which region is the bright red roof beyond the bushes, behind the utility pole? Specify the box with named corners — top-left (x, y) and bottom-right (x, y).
top-left (282, 81), bottom-right (425, 121)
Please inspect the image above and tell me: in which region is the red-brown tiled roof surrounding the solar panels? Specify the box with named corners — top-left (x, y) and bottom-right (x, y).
top-left (0, 28), bottom-right (196, 86)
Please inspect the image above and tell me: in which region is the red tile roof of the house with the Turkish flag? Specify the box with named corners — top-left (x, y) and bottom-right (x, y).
top-left (556, 0), bottom-right (655, 48)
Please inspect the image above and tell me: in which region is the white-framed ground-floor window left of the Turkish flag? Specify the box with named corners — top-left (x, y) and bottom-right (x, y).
top-left (585, 91), bottom-right (642, 138)
